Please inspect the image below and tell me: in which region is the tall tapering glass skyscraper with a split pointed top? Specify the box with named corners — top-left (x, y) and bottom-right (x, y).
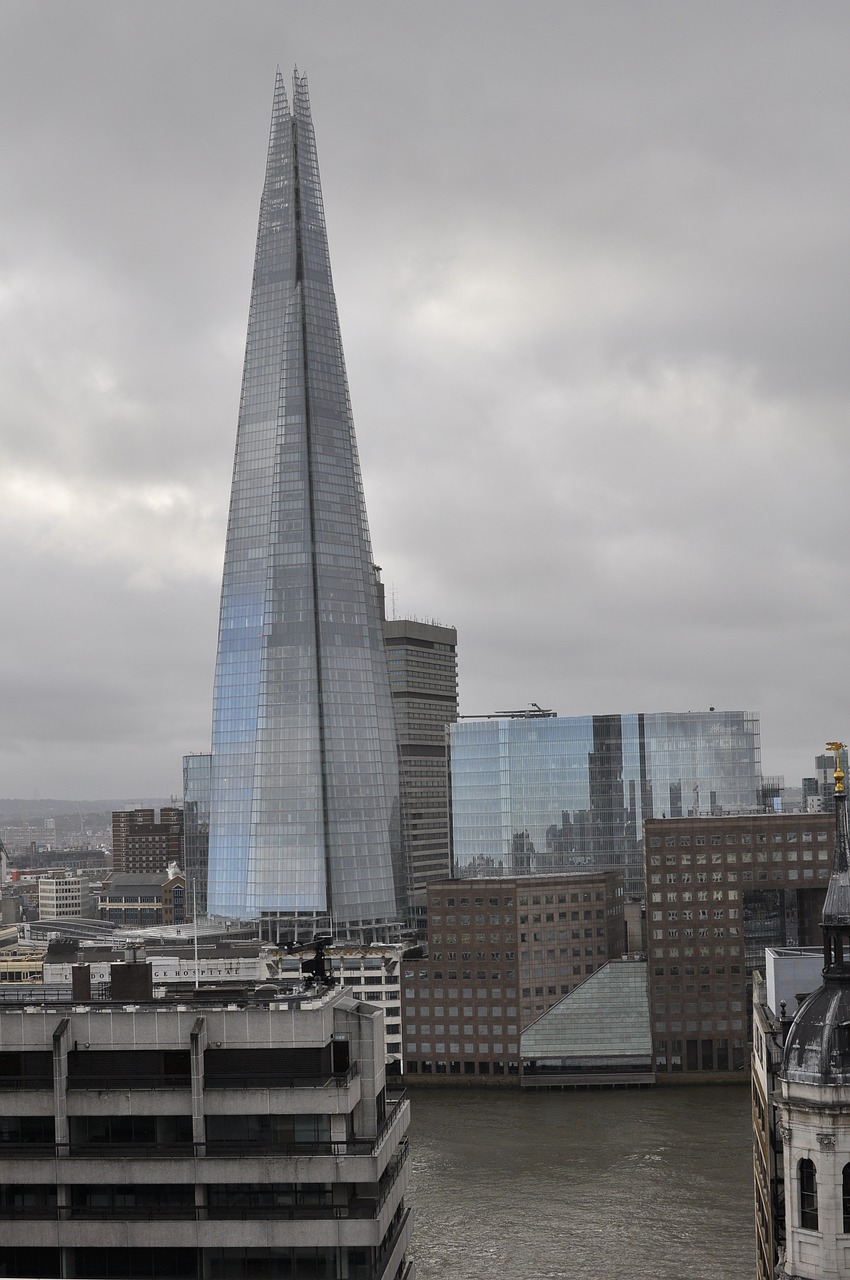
top-left (207, 72), bottom-right (403, 940)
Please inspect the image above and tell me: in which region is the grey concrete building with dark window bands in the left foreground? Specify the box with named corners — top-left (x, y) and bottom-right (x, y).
top-left (0, 964), bottom-right (412, 1280)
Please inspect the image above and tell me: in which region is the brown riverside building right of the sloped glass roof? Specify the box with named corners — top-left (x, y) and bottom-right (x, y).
top-left (645, 813), bottom-right (833, 1079)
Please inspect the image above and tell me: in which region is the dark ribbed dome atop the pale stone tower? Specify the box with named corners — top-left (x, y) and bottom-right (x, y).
top-left (782, 980), bottom-right (850, 1084)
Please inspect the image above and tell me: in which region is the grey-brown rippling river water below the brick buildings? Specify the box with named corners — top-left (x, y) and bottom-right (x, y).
top-left (408, 1085), bottom-right (755, 1280)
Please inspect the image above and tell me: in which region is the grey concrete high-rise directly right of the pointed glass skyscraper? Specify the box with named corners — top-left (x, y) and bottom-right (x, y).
top-left (384, 618), bottom-right (457, 899)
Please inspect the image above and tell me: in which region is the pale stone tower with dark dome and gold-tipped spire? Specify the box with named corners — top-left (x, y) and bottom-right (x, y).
top-left (777, 742), bottom-right (850, 1280)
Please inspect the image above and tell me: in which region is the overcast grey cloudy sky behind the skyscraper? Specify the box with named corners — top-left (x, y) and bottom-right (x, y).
top-left (0, 0), bottom-right (850, 799)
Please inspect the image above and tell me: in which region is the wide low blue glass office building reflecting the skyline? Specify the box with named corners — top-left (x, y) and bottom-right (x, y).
top-left (449, 712), bottom-right (762, 896)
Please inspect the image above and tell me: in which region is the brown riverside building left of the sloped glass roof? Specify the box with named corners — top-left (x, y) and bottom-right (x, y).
top-left (402, 872), bottom-right (625, 1076)
